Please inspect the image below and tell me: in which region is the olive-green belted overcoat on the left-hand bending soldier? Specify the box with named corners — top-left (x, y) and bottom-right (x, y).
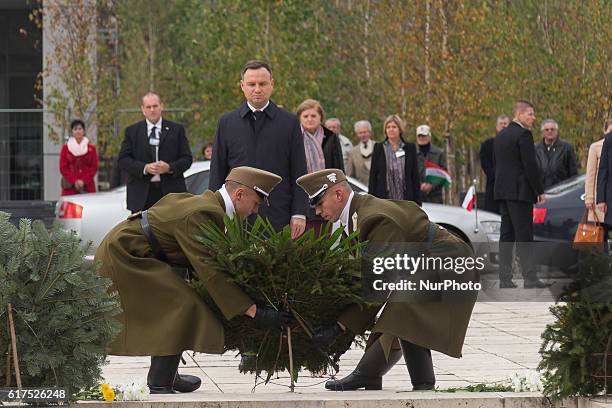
top-left (96, 191), bottom-right (253, 356)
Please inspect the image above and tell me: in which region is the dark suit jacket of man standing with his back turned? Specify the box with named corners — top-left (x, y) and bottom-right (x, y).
top-left (494, 122), bottom-right (544, 203)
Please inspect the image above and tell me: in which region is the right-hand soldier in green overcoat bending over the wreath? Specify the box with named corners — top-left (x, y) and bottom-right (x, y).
top-left (296, 169), bottom-right (479, 390)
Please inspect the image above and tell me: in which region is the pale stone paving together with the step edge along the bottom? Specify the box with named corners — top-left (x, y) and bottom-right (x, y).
top-left (87, 302), bottom-right (612, 408)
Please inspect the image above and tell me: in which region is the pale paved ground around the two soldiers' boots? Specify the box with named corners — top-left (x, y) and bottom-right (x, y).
top-left (104, 302), bottom-right (552, 401)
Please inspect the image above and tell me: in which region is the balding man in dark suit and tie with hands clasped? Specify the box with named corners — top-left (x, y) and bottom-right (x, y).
top-left (118, 92), bottom-right (193, 213)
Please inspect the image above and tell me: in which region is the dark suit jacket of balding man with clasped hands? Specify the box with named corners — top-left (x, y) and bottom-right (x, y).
top-left (118, 118), bottom-right (193, 211)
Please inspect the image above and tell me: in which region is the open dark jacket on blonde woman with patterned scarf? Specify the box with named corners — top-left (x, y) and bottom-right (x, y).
top-left (368, 139), bottom-right (422, 205)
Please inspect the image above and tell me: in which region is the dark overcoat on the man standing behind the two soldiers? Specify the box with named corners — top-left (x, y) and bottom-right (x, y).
top-left (209, 101), bottom-right (308, 230)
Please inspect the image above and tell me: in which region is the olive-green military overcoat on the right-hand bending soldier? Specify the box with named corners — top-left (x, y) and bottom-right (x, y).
top-left (338, 194), bottom-right (479, 357)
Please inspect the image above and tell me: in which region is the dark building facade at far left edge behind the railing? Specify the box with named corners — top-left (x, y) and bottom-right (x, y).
top-left (0, 0), bottom-right (44, 201)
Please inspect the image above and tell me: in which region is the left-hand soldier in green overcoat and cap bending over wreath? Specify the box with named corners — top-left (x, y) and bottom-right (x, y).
top-left (96, 167), bottom-right (291, 393)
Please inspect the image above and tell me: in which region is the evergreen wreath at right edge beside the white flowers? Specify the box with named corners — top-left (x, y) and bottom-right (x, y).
top-left (538, 250), bottom-right (612, 399)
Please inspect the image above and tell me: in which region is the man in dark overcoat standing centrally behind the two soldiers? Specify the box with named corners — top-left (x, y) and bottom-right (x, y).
top-left (209, 61), bottom-right (308, 238)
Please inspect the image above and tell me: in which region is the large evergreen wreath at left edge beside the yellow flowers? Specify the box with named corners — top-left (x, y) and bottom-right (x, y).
top-left (0, 212), bottom-right (120, 393)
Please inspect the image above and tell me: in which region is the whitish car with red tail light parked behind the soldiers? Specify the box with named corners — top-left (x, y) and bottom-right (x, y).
top-left (55, 161), bottom-right (501, 271)
